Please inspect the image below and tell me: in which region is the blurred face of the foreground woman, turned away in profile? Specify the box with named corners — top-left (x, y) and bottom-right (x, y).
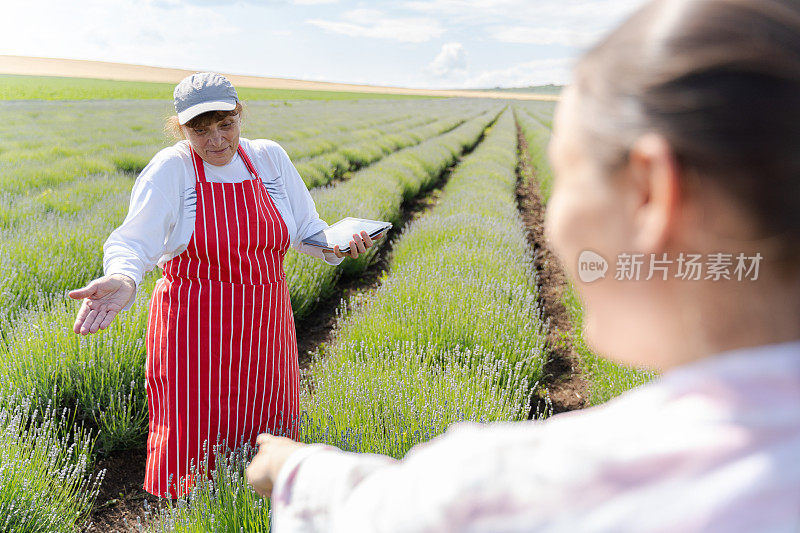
top-left (545, 89), bottom-right (652, 364)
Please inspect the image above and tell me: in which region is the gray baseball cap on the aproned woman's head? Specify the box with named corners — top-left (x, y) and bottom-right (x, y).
top-left (173, 72), bottom-right (239, 124)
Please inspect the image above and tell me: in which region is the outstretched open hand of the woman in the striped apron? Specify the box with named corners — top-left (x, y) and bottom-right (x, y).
top-left (69, 274), bottom-right (136, 335)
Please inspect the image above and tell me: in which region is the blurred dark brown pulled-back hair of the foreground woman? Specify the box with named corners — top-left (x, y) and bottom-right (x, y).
top-left (575, 0), bottom-right (800, 260)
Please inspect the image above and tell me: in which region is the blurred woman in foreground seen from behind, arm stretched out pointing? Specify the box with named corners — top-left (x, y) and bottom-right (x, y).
top-left (248, 0), bottom-right (800, 532)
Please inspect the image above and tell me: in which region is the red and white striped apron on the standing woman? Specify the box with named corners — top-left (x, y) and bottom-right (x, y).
top-left (144, 145), bottom-right (300, 498)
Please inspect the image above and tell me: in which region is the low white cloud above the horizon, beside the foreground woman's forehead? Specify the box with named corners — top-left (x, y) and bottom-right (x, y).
top-left (464, 58), bottom-right (573, 89)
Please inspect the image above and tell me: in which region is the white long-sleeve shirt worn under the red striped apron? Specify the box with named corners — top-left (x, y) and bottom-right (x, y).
top-left (103, 138), bottom-right (343, 301)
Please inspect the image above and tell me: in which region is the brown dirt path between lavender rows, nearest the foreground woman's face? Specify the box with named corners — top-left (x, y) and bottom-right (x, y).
top-left (517, 118), bottom-right (587, 416)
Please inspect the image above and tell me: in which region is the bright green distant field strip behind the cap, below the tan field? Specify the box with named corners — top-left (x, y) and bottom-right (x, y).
top-left (0, 74), bottom-right (431, 101)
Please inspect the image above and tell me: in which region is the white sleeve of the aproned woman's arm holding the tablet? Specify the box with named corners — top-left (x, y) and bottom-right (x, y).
top-left (274, 144), bottom-right (344, 266)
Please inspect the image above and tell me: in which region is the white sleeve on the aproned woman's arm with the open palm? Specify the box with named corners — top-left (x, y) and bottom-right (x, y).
top-left (103, 155), bottom-right (184, 310)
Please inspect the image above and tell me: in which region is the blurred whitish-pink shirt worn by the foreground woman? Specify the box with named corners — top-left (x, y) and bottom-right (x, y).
top-left (272, 342), bottom-right (800, 533)
